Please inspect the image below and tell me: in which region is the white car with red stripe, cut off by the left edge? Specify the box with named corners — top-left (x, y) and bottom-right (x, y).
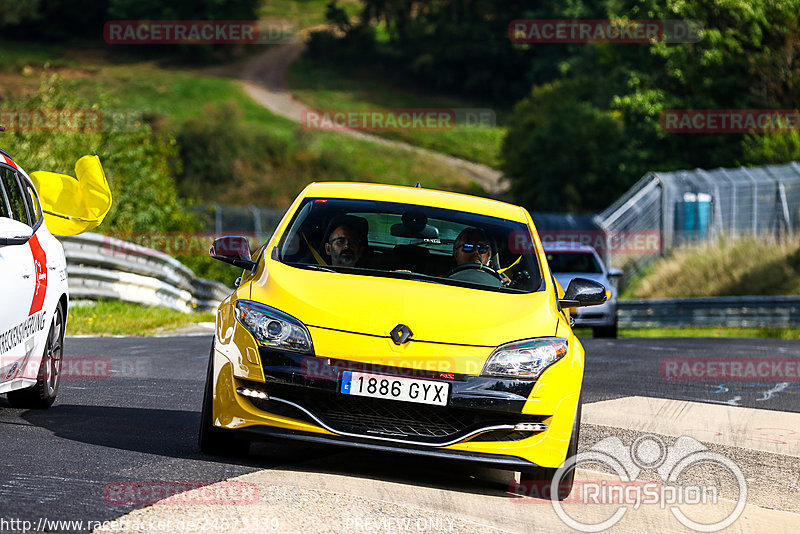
top-left (0, 150), bottom-right (69, 408)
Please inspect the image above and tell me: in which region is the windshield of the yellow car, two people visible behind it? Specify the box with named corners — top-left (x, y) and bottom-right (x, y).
top-left (277, 198), bottom-right (541, 293)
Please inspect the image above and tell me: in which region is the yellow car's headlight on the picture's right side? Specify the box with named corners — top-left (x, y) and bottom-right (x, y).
top-left (481, 337), bottom-right (567, 378)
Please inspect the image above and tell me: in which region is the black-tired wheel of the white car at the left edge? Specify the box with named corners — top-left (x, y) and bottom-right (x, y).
top-left (6, 302), bottom-right (64, 410)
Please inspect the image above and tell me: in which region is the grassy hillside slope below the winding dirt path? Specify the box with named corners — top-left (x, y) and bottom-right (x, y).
top-left (0, 38), bottom-right (481, 207)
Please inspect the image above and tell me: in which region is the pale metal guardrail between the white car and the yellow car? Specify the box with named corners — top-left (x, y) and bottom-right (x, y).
top-left (61, 233), bottom-right (232, 312)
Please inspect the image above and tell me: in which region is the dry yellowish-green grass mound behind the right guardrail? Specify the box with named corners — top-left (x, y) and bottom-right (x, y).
top-left (623, 237), bottom-right (800, 298)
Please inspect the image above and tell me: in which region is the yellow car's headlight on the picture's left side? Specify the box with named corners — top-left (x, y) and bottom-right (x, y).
top-left (235, 300), bottom-right (314, 354)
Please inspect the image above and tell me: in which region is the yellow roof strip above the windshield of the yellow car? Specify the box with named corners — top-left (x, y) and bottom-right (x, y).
top-left (296, 182), bottom-right (528, 224)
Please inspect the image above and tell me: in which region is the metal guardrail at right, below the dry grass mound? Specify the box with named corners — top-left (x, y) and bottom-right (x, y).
top-left (618, 295), bottom-right (800, 328)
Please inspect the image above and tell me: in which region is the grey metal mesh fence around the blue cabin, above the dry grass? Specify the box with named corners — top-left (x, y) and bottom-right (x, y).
top-left (594, 162), bottom-right (800, 275)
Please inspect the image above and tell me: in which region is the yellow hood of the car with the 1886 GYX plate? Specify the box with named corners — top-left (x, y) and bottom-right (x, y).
top-left (251, 261), bottom-right (557, 347)
